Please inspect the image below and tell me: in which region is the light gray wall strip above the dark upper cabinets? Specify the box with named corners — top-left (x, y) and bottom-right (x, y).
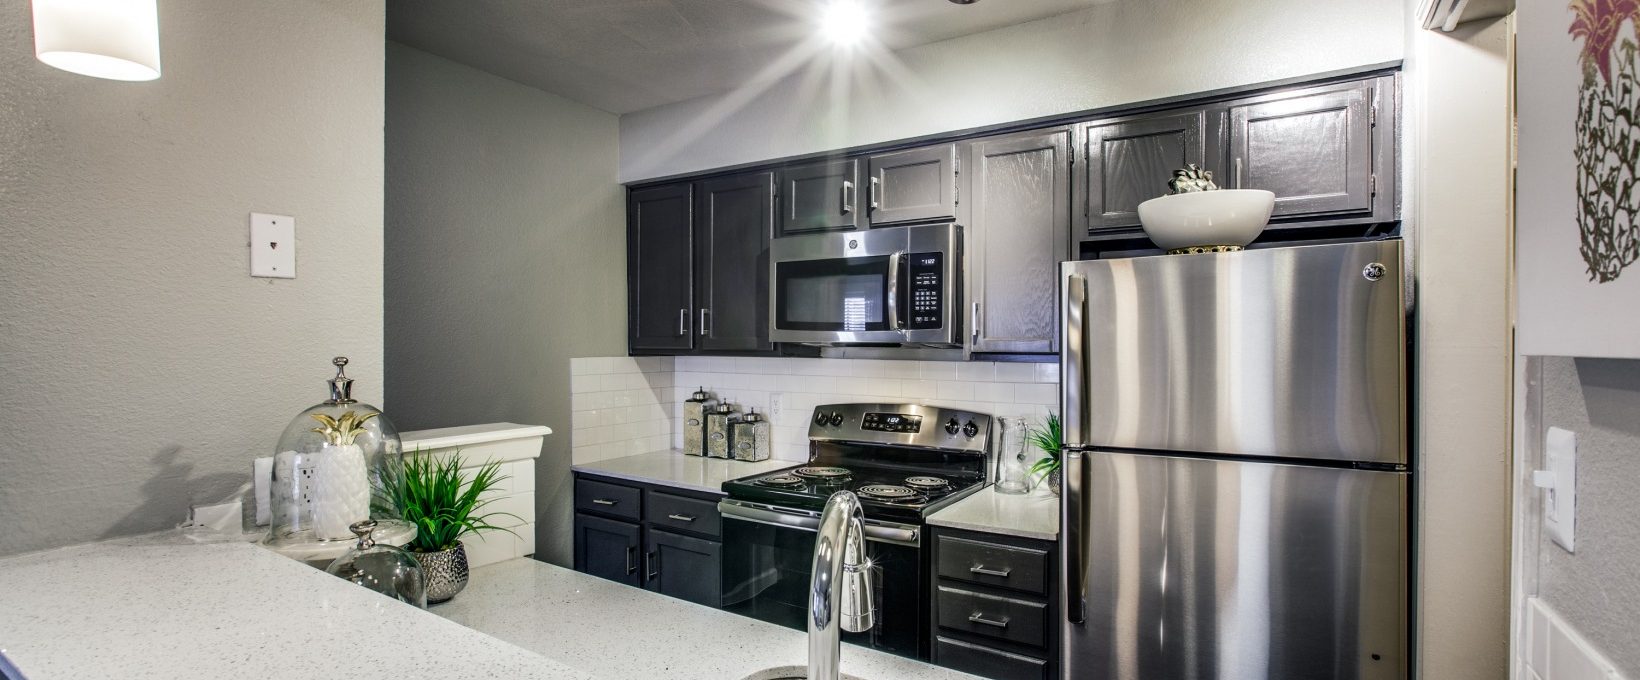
top-left (620, 0), bottom-right (1405, 182)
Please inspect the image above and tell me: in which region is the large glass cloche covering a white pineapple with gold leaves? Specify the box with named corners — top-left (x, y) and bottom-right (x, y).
top-left (267, 357), bottom-right (400, 546)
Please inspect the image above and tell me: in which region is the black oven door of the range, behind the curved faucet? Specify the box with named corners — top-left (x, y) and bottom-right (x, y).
top-left (718, 500), bottom-right (928, 659)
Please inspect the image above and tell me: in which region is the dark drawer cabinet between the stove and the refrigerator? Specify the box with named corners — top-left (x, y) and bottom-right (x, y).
top-left (928, 526), bottom-right (1061, 680)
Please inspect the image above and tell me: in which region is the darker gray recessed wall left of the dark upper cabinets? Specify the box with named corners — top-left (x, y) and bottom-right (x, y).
top-left (385, 43), bottom-right (626, 565)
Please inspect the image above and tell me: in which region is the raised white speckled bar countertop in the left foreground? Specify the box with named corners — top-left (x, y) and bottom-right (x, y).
top-left (0, 539), bottom-right (594, 680)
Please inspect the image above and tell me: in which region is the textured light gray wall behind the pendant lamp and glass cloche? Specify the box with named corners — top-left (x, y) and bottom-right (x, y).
top-left (0, 0), bottom-right (384, 554)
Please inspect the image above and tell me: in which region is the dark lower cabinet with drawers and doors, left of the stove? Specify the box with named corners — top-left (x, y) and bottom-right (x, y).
top-left (576, 472), bottom-right (723, 608)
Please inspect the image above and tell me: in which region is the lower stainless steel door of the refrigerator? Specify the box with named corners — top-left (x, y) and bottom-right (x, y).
top-left (1061, 452), bottom-right (1407, 680)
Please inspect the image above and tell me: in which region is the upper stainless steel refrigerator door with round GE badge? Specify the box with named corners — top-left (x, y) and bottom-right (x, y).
top-left (1061, 241), bottom-right (1407, 464)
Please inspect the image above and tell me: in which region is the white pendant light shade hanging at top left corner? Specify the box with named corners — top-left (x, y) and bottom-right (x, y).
top-left (34, 0), bottom-right (159, 80)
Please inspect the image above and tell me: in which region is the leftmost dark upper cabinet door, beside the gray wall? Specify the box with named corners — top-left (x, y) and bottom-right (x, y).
top-left (626, 184), bottom-right (694, 351)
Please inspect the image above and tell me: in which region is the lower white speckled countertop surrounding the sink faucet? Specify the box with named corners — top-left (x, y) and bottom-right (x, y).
top-left (433, 559), bottom-right (974, 680)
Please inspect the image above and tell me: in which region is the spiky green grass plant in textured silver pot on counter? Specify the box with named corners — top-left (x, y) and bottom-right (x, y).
top-left (372, 449), bottom-right (517, 605)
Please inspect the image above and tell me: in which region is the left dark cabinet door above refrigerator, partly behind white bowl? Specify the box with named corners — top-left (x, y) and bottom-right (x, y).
top-left (1077, 110), bottom-right (1219, 231)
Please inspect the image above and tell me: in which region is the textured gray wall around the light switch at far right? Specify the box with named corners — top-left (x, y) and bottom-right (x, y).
top-left (1530, 357), bottom-right (1640, 678)
